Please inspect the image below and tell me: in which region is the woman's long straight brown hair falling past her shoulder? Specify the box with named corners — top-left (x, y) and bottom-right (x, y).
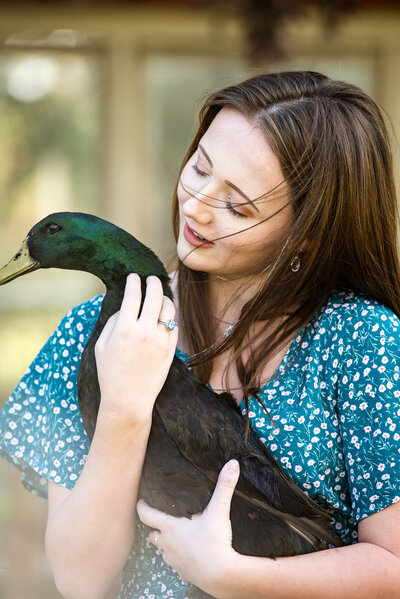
top-left (173, 71), bottom-right (400, 408)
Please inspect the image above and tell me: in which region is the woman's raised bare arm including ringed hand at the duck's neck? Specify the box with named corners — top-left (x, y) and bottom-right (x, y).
top-left (46, 275), bottom-right (177, 599)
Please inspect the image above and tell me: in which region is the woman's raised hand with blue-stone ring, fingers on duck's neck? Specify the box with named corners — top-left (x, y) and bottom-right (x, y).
top-left (95, 274), bottom-right (178, 424)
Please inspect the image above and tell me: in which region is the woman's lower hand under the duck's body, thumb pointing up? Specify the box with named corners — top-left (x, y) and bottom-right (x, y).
top-left (137, 460), bottom-right (239, 594)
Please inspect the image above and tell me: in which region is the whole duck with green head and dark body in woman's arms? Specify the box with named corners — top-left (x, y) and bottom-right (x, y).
top-left (0, 212), bottom-right (343, 599)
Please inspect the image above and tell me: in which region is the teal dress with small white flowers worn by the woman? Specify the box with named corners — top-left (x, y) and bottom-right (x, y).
top-left (0, 293), bottom-right (400, 599)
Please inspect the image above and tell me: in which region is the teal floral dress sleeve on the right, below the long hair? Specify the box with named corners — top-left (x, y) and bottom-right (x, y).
top-left (337, 300), bottom-right (400, 523)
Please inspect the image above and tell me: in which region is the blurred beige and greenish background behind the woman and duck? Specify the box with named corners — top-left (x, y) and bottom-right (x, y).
top-left (0, 0), bottom-right (400, 599)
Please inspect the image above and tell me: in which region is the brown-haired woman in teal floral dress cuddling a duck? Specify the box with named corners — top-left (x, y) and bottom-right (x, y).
top-left (0, 72), bottom-right (400, 599)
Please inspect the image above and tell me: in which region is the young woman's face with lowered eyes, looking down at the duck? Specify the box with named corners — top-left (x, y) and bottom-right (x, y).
top-left (177, 108), bottom-right (293, 278)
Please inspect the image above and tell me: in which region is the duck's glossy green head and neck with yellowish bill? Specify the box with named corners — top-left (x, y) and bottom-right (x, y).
top-left (0, 212), bottom-right (171, 297)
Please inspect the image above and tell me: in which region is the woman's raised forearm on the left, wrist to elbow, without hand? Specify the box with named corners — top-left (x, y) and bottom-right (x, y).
top-left (46, 420), bottom-right (149, 599)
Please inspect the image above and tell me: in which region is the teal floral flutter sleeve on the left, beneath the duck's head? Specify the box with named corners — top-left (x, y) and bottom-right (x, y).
top-left (0, 296), bottom-right (102, 497)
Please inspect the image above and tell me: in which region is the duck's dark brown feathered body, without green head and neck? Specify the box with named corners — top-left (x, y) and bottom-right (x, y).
top-left (78, 288), bottom-right (341, 597)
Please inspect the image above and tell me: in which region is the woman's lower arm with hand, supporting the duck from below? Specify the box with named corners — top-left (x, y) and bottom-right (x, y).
top-left (138, 462), bottom-right (400, 599)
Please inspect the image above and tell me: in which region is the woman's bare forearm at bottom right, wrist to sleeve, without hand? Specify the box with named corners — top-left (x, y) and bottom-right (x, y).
top-left (220, 503), bottom-right (400, 599)
